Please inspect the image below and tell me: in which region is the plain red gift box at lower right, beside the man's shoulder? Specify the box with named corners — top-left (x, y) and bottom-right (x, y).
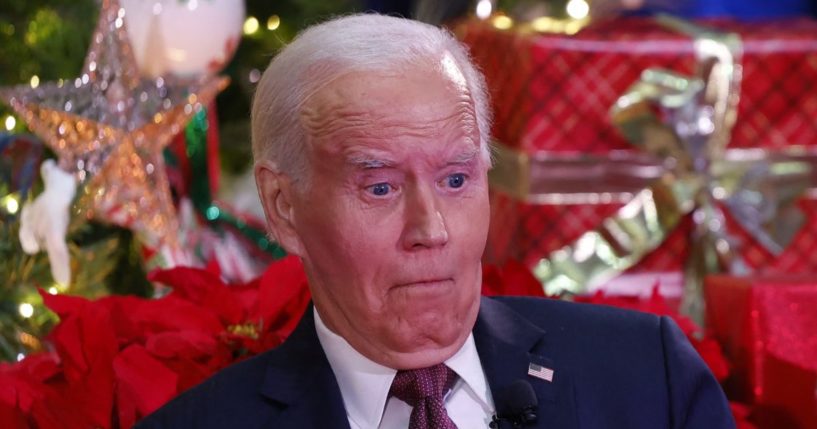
top-left (705, 275), bottom-right (817, 429)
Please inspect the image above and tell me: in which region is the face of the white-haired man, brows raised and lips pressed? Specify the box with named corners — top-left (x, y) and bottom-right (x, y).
top-left (284, 62), bottom-right (489, 368)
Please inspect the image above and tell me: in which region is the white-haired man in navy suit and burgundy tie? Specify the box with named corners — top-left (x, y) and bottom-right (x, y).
top-left (137, 15), bottom-right (734, 429)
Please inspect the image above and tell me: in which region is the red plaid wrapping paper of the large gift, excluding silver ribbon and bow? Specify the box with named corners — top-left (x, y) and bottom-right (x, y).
top-left (455, 18), bottom-right (817, 290)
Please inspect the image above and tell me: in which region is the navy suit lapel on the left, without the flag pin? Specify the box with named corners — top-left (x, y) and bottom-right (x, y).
top-left (259, 305), bottom-right (349, 428)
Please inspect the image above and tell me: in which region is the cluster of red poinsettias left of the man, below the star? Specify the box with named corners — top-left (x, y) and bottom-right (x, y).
top-left (0, 258), bottom-right (310, 429)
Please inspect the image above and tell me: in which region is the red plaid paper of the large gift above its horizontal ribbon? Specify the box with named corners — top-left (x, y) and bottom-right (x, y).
top-left (457, 18), bottom-right (817, 154)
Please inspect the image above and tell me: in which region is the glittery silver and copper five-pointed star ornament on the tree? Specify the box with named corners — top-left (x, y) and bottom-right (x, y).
top-left (0, 0), bottom-right (227, 247)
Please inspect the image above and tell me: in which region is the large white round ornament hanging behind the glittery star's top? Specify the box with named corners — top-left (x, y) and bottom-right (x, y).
top-left (121, 0), bottom-right (245, 77)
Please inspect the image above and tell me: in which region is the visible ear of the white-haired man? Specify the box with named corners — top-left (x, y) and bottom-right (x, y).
top-left (255, 160), bottom-right (304, 257)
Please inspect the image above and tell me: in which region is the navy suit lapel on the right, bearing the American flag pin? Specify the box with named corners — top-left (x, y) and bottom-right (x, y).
top-left (474, 298), bottom-right (578, 429)
